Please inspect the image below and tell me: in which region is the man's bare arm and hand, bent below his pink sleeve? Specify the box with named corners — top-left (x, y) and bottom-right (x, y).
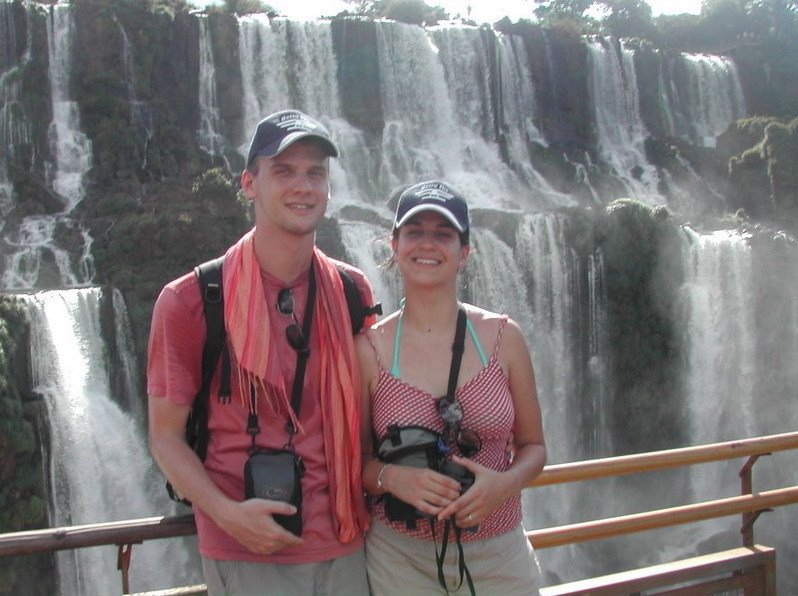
top-left (148, 396), bottom-right (303, 554)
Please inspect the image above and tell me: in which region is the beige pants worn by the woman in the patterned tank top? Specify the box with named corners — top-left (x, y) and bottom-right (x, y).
top-left (366, 518), bottom-right (540, 596)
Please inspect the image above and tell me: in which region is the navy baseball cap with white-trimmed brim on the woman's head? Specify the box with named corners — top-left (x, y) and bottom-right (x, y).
top-left (393, 180), bottom-right (469, 244)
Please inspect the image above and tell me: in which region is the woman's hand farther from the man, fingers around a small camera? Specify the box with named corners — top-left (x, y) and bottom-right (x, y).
top-left (438, 455), bottom-right (517, 528)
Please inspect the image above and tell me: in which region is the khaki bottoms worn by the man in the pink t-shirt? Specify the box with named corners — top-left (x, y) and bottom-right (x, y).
top-left (202, 549), bottom-right (369, 596)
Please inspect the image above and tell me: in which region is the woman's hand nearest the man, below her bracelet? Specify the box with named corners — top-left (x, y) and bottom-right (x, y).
top-left (382, 465), bottom-right (460, 517)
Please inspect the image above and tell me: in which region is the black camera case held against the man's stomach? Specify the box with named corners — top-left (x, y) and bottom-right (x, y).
top-left (244, 449), bottom-right (305, 536)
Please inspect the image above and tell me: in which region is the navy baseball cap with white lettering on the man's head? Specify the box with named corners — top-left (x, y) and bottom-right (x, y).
top-left (247, 110), bottom-right (338, 167)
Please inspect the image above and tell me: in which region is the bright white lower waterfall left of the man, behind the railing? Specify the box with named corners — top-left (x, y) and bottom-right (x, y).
top-left (26, 289), bottom-right (198, 594)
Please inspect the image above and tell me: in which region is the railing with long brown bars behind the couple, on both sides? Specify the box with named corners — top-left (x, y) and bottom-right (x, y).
top-left (0, 432), bottom-right (798, 594)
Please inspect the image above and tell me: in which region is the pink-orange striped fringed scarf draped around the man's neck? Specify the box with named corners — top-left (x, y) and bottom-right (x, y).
top-left (223, 231), bottom-right (369, 543)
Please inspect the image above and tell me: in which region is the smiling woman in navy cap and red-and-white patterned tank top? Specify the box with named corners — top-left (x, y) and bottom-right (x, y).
top-left (356, 181), bottom-right (546, 596)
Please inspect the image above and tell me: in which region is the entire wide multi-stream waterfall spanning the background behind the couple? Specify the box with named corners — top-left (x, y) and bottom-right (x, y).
top-left (0, 7), bottom-right (798, 594)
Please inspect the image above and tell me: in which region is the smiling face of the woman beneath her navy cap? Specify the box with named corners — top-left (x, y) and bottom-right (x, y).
top-left (391, 211), bottom-right (469, 283)
